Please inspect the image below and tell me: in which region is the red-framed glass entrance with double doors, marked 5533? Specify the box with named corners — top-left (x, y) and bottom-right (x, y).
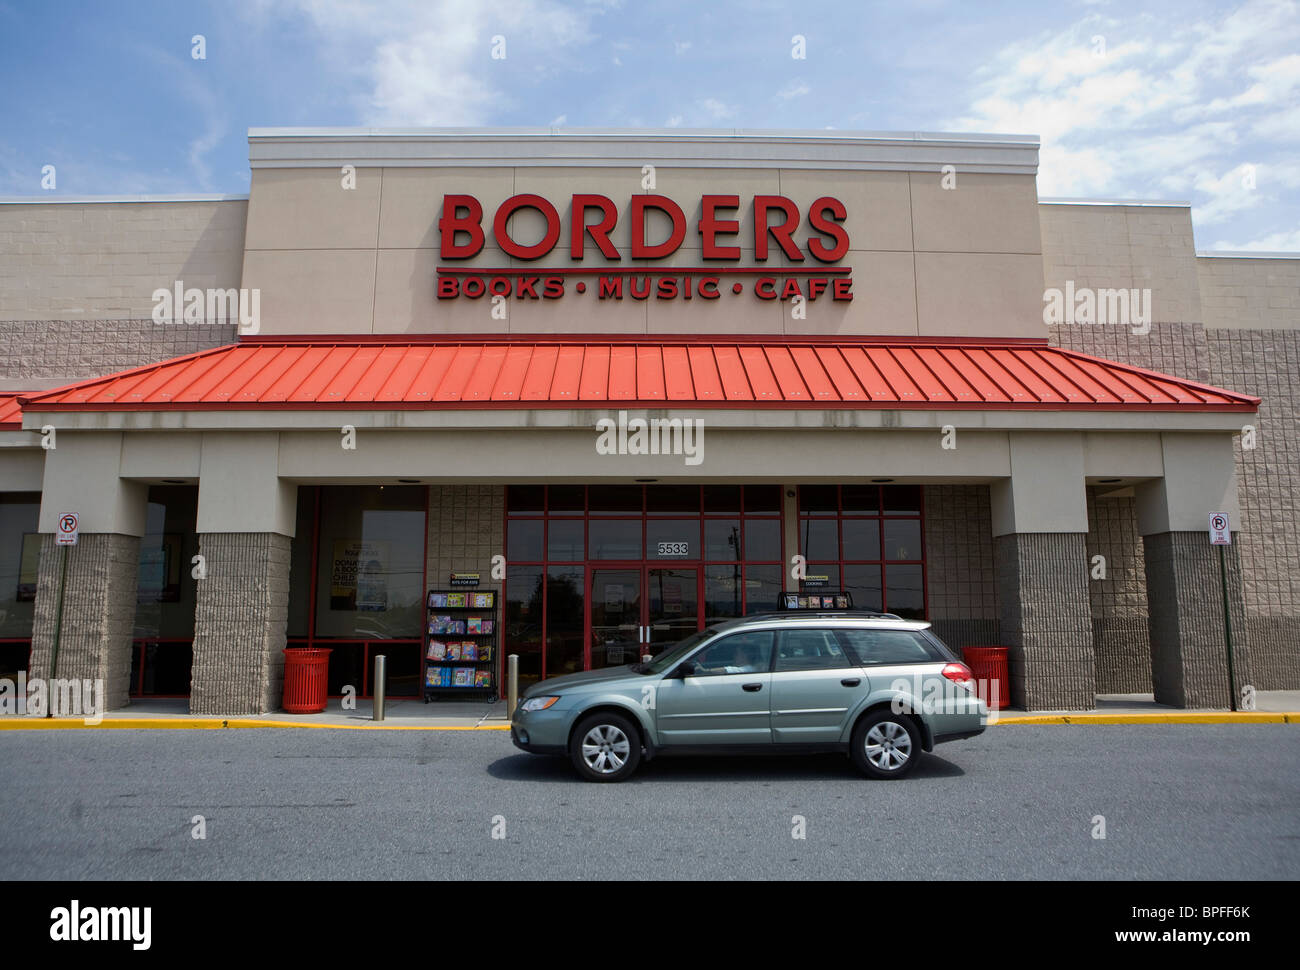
top-left (504, 485), bottom-right (780, 681)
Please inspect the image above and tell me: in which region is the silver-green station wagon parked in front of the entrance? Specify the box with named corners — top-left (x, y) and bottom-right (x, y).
top-left (510, 610), bottom-right (988, 781)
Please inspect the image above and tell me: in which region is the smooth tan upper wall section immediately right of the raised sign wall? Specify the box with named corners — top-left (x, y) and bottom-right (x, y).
top-left (1039, 203), bottom-right (1203, 324)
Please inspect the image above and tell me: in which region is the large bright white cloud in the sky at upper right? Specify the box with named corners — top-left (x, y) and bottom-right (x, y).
top-left (950, 0), bottom-right (1300, 224)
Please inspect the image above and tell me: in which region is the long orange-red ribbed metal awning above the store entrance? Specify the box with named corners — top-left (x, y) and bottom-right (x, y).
top-left (12, 334), bottom-right (1260, 415)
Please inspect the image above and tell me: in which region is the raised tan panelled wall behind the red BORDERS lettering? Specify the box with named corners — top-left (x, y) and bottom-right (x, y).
top-left (243, 165), bottom-right (1047, 337)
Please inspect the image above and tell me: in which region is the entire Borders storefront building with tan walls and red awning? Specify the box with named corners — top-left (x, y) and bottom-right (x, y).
top-left (0, 130), bottom-right (1300, 714)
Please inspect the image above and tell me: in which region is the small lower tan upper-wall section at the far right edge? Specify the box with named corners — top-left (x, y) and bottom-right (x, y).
top-left (1196, 254), bottom-right (1300, 330)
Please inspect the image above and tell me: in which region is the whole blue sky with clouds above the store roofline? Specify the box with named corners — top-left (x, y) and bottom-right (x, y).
top-left (0, 0), bottom-right (1300, 251)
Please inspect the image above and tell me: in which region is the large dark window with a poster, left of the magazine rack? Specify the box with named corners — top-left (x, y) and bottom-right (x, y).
top-left (315, 485), bottom-right (428, 640)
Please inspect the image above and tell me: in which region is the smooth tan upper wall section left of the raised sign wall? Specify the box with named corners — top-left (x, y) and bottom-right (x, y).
top-left (0, 199), bottom-right (248, 320)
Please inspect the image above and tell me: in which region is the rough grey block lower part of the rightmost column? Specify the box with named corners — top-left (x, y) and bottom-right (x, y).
top-left (1144, 532), bottom-right (1253, 710)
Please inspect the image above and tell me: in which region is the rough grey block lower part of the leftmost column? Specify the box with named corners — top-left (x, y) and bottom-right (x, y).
top-left (29, 533), bottom-right (140, 710)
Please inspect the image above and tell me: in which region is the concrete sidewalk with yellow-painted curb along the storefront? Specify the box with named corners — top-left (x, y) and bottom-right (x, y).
top-left (0, 690), bottom-right (1300, 731)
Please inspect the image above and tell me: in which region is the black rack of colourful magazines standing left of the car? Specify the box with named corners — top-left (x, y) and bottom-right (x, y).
top-left (421, 588), bottom-right (501, 703)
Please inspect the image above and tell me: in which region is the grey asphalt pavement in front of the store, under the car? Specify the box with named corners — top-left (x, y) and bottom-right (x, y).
top-left (0, 724), bottom-right (1300, 880)
